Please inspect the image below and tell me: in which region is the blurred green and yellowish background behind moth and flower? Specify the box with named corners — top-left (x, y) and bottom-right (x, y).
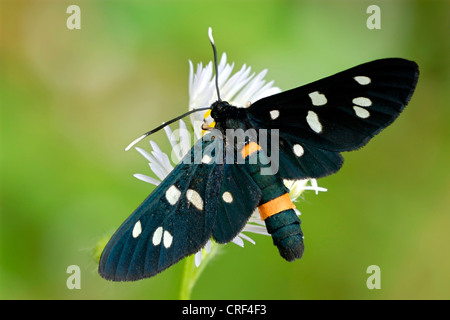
top-left (0, 0), bottom-right (450, 299)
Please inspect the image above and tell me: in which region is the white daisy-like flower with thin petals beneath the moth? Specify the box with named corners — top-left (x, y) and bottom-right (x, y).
top-left (134, 53), bottom-right (326, 266)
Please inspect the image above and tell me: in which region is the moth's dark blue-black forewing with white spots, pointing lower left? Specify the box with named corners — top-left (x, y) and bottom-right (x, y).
top-left (99, 135), bottom-right (223, 281)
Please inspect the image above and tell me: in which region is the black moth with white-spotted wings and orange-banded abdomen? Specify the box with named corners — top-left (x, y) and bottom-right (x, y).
top-left (99, 31), bottom-right (419, 281)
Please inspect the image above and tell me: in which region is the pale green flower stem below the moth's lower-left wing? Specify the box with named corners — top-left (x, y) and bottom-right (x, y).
top-left (180, 241), bottom-right (221, 300)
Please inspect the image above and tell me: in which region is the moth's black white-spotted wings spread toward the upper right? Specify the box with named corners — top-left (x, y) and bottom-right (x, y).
top-left (248, 58), bottom-right (419, 179)
